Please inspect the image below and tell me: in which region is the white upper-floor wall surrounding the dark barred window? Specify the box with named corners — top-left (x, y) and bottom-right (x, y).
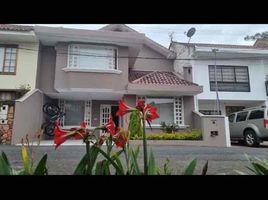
top-left (192, 60), bottom-right (266, 101)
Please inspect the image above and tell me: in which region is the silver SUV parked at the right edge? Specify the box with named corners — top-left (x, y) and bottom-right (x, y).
top-left (229, 106), bottom-right (268, 147)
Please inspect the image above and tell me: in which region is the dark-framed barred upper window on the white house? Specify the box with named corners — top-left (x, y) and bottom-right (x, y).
top-left (209, 65), bottom-right (250, 92)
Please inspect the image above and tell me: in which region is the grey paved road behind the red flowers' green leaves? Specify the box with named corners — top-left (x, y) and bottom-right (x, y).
top-left (0, 143), bottom-right (268, 175)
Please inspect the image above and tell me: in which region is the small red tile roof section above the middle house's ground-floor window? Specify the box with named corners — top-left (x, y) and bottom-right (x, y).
top-left (129, 71), bottom-right (197, 86)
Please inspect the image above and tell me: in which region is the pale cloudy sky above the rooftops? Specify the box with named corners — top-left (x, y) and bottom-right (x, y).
top-left (28, 24), bottom-right (268, 47)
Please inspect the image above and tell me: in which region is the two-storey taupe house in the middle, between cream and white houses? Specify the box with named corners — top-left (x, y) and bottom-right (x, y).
top-left (13, 25), bottom-right (202, 143)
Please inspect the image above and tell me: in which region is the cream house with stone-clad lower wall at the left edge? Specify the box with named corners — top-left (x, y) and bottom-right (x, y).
top-left (0, 24), bottom-right (39, 144)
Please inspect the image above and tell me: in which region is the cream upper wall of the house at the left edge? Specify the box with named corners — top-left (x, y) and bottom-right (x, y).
top-left (0, 42), bottom-right (39, 90)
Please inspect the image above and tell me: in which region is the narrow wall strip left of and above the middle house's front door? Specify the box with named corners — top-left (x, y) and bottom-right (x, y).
top-left (91, 100), bottom-right (118, 127)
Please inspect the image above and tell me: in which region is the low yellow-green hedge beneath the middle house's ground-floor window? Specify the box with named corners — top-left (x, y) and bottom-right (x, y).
top-left (131, 129), bottom-right (202, 140)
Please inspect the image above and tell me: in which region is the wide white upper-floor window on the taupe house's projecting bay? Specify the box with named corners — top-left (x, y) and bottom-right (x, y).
top-left (68, 44), bottom-right (117, 70)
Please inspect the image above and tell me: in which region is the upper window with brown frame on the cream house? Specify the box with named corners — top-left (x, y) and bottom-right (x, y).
top-left (0, 46), bottom-right (18, 74)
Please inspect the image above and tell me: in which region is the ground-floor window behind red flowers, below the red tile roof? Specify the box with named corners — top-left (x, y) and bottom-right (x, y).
top-left (146, 97), bottom-right (174, 125)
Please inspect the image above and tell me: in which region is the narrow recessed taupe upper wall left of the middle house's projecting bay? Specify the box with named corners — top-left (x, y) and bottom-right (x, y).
top-left (39, 46), bottom-right (56, 93)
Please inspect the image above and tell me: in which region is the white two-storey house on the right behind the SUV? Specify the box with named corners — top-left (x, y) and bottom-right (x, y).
top-left (169, 42), bottom-right (268, 115)
